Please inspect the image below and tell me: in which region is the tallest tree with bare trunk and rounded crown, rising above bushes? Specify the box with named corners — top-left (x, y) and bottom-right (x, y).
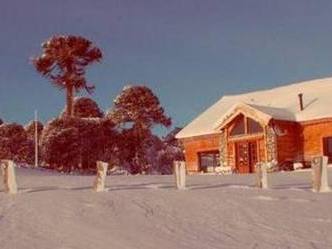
top-left (33, 35), bottom-right (102, 117)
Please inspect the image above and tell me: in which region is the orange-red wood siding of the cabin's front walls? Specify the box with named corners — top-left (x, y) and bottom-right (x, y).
top-left (182, 119), bottom-right (332, 171)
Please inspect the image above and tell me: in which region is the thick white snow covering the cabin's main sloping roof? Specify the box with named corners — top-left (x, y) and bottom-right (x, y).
top-left (176, 77), bottom-right (332, 138)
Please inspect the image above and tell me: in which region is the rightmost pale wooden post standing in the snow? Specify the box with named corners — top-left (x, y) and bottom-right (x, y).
top-left (311, 156), bottom-right (330, 192)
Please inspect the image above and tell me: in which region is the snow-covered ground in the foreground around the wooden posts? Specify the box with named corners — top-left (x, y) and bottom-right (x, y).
top-left (0, 169), bottom-right (332, 249)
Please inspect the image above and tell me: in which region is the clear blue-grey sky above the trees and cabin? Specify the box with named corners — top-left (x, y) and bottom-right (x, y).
top-left (0, 0), bottom-right (332, 135)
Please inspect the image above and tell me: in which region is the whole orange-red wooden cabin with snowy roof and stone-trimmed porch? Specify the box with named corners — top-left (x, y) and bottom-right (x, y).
top-left (176, 78), bottom-right (332, 173)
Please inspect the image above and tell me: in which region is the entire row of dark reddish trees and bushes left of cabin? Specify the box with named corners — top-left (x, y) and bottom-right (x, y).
top-left (0, 36), bottom-right (183, 174)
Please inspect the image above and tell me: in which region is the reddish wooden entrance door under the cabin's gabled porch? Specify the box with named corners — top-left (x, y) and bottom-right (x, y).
top-left (235, 141), bottom-right (258, 173)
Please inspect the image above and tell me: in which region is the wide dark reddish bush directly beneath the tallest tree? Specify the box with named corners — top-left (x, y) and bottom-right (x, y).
top-left (41, 118), bottom-right (116, 171)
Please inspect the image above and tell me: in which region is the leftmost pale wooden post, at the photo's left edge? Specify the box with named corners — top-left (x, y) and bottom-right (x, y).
top-left (0, 160), bottom-right (17, 194)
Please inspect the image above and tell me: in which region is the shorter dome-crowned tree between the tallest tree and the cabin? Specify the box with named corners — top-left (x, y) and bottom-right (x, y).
top-left (107, 86), bottom-right (171, 173)
